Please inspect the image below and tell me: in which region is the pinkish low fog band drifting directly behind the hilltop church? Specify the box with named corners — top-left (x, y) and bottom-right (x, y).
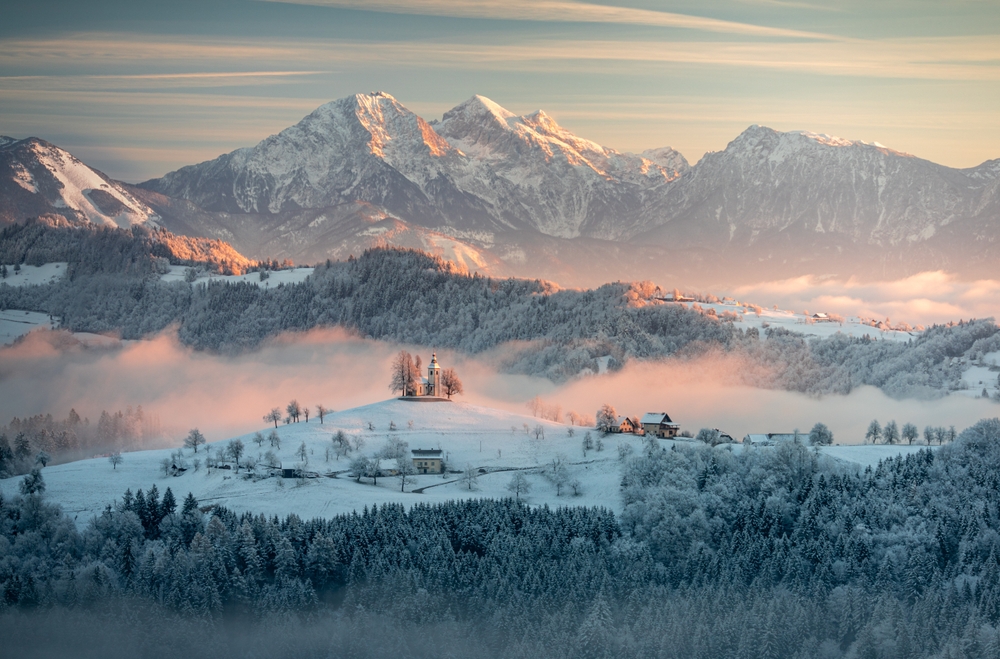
top-left (0, 330), bottom-right (1000, 452)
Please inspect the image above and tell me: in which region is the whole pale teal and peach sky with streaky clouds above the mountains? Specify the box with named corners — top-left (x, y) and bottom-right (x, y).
top-left (0, 0), bottom-right (1000, 181)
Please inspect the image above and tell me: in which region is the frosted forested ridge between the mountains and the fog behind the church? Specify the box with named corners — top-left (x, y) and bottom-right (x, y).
top-left (0, 224), bottom-right (1000, 397)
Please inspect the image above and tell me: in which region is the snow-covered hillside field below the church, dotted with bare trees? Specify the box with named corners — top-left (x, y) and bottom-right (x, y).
top-left (0, 399), bottom-right (936, 524)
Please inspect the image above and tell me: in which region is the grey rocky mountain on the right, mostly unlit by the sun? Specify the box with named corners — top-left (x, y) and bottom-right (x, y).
top-left (640, 126), bottom-right (998, 249)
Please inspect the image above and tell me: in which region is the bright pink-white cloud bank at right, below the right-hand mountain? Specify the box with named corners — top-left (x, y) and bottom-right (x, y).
top-left (732, 271), bottom-right (1000, 325)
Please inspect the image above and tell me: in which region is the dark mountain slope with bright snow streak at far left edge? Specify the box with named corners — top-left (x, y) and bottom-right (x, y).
top-left (0, 136), bottom-right (158, 227)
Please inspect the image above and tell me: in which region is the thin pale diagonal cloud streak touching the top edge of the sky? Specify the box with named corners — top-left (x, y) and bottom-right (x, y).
top-left (268, 0), bottom-right (841, 40)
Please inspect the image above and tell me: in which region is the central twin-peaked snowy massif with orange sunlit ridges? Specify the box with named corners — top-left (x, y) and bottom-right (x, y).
top-left (140, 92), bottom-right (687, 244)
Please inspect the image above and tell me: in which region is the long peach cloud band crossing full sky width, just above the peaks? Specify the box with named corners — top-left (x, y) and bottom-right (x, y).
top-left (0, 34), bottom-right (1000, 82)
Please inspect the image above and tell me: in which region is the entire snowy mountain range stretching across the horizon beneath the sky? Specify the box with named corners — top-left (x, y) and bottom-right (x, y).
top-left (0, 92), bottom-right (1000, 284)
